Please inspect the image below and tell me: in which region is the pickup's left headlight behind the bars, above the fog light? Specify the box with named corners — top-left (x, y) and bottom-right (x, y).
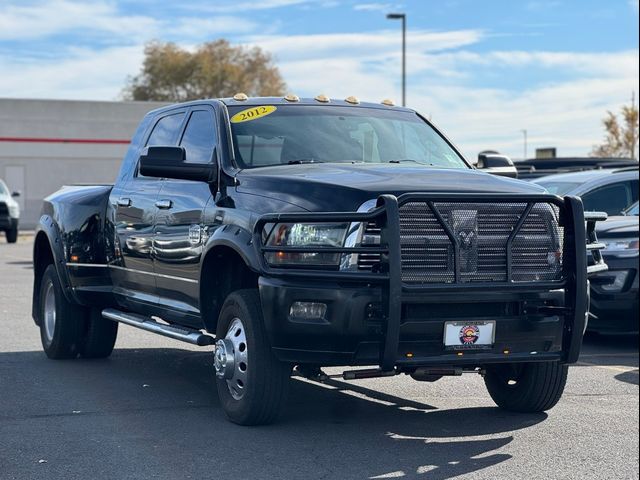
top-left (265, 223), bottom-right (348, 267)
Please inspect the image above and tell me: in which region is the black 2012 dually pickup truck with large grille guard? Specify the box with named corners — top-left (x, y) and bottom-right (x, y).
top-left (33, 94), bottom-right (606, 425)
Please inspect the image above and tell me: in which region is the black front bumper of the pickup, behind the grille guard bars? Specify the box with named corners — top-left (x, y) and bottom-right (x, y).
top-left (259, 277), bottom-right (566, 367)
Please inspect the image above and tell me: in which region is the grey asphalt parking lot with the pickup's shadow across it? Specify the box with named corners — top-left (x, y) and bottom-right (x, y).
top-left (0, 238), bottom-right (638, 480)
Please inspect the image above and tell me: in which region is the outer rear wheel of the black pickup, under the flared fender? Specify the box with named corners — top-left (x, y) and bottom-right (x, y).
top-left (38, 265), bottom-right (87, 360)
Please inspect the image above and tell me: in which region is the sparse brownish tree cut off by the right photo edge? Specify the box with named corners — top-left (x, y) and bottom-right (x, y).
top-left (591, 99), bottom-right (638, 159)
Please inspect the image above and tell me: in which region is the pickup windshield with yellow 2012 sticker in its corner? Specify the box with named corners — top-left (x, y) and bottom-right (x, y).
top-left (229, 105), bottom-right (469, 168)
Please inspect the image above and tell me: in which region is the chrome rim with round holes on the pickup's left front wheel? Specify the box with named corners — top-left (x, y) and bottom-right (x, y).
top-left (214, 317), bottom-right (249, 400)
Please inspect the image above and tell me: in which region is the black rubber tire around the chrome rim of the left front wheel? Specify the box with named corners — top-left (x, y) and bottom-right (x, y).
top-left (216, 290), bottom-right (291, 425)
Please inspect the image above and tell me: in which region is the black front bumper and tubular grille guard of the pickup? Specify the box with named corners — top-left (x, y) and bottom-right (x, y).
top-left (253, 194), bottom-right (606, 371)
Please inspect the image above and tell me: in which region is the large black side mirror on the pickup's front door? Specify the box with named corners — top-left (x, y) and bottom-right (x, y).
top-left (139, 146), bottom-right (217, 182)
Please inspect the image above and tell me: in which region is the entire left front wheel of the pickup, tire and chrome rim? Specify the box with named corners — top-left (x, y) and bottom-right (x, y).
top-left (214, 290), bottom-right (291, 425)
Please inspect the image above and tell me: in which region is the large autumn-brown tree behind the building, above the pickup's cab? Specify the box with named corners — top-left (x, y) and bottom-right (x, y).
top-left (123, 40), bottom-right (285, 102)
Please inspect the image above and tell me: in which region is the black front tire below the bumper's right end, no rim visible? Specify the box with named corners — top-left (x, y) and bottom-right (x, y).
top-left (484, 362), bottom-right (569, 413)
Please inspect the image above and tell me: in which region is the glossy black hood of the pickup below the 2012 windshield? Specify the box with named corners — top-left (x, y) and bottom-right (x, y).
top-left (236, 163), bottom-right (545, 211)
